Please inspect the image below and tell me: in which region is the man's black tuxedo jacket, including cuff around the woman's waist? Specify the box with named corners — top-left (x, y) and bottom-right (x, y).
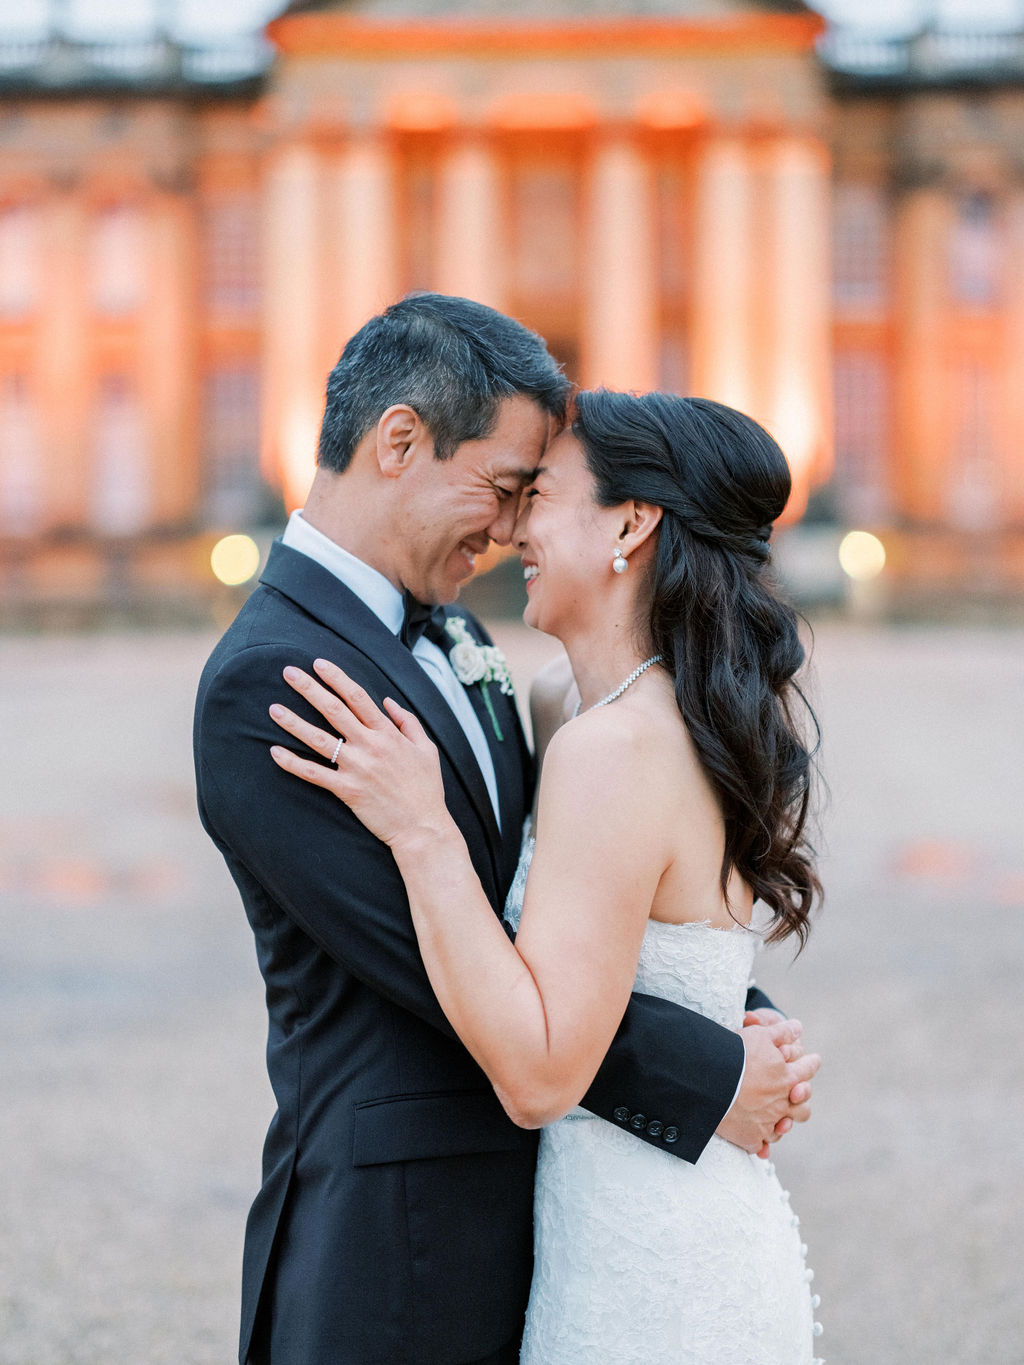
top-left (194, 543), bottom-right (770, 1365)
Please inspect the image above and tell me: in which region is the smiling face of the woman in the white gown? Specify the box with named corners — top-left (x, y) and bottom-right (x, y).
top-left (513, 427), bottom-right (618, 637)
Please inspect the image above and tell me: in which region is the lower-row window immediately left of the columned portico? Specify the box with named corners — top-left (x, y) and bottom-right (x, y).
top-left (203, 362), bottom-right (268, 527)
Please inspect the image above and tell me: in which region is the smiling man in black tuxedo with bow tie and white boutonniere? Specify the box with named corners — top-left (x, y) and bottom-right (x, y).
top-left (195, 295), bottom-right (814, 1365)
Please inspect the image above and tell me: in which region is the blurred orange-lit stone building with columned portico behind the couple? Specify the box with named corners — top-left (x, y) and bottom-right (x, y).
top-left (0, 0), bottom-right (1024, 619)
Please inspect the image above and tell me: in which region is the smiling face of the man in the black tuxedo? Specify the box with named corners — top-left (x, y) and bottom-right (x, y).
top-left (400, 394), bottom-right (552, 603)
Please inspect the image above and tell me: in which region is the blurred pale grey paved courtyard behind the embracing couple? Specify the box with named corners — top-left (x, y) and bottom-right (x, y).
top-left (0, 624), bottom-right (1024, 1365)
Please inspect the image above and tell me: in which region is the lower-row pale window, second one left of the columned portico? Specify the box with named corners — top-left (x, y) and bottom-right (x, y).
top-left (91, 374), bottom-right (152, 535)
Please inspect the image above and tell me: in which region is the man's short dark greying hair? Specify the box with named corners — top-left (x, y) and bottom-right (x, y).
top-left (317, 293), bottom-right (571, 474)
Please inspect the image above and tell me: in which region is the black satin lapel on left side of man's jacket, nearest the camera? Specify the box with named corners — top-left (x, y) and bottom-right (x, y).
top-left (259, 541), bottom-right (501, 872)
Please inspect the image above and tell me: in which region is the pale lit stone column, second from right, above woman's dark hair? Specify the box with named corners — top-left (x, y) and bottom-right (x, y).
top-left (692, 134), bottom-right (756, 412)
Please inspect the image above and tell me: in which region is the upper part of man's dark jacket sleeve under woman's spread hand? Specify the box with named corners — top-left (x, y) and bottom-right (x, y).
top-left (195, 646), bottom-right (472, 1037)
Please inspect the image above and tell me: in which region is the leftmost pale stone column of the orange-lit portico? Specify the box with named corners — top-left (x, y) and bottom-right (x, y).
top-left (261, 141), bottom-right (326, 512)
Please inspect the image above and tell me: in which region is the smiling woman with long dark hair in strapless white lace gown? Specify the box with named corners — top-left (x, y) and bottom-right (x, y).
top-left (272, 390), bottom-right (821, 1365)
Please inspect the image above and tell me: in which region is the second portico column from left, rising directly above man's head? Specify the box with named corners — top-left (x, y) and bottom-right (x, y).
top-left (329, 134), bottom-right (400, 346)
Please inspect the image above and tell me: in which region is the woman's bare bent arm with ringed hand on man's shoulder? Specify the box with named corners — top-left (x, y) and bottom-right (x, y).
top-left (272, 665), bottom-right (665, 1127)
